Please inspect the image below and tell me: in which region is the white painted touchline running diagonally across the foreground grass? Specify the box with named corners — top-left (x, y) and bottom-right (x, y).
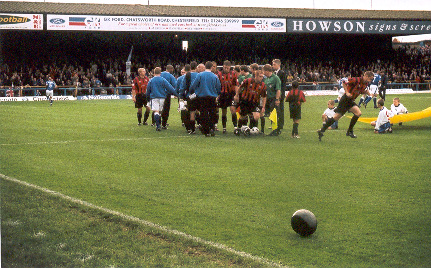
top-left (0, 174), bottom-right (288, 268)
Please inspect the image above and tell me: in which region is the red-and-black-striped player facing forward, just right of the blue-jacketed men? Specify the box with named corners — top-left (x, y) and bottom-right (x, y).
top-left (217, 60), bottom-right (238, 133)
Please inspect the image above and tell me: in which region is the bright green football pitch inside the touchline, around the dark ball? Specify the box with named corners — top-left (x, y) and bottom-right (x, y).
top-left (0, 93), bottom-right (431, 267)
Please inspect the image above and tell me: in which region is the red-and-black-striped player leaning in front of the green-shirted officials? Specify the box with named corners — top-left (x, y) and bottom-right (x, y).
top-left (234, 70), bottom-right (266, 129)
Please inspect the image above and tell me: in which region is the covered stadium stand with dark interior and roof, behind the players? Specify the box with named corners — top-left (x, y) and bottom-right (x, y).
top-left (0, 2), bottom-right (431, 96)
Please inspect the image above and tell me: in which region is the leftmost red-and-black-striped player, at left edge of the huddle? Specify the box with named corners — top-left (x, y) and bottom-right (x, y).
top-left (132, 68), bottom-right (150, 126)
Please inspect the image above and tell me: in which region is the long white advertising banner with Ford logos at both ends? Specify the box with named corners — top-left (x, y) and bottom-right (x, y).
top-left (47, 14), bottom-right (286, 33)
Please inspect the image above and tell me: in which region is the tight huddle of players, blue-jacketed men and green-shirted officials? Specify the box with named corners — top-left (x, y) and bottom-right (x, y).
top-left (132, 59), bottom-right (286, 136)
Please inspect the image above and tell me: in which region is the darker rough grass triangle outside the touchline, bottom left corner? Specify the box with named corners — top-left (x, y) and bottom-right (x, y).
top-left (2, 178), bottom-right (264, 267)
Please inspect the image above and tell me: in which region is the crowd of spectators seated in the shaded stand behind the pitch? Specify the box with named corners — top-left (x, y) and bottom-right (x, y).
top-left (0, 31), bottom-right (431, 95)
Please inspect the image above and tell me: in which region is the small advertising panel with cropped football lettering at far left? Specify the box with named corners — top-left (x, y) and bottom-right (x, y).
top-left (0, 13), bottom-right (43, 30)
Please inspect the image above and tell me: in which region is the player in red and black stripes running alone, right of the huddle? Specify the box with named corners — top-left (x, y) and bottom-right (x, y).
top-left (317, 71), bottom-right (374, 141)
